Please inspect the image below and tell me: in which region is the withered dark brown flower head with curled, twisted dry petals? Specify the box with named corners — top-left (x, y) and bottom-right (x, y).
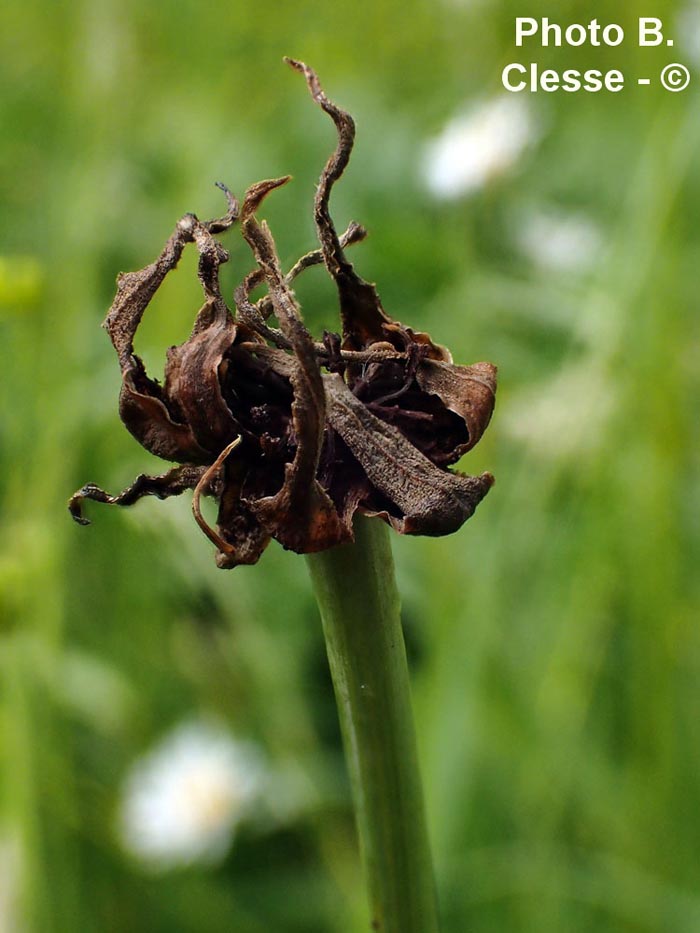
top-left (69, 59), bottom-right (496, 568)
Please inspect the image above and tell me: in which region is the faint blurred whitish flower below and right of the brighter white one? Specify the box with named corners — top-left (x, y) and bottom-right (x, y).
top-left (517, 211), bottom-right (602, 272)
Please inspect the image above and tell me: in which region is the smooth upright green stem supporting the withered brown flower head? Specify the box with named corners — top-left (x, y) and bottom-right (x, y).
top-left (308, 518), bottom-right (438, 933)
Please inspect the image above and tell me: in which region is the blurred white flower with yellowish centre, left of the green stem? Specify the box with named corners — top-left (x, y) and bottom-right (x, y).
top-left (119, 721), bottom-right (265, 871)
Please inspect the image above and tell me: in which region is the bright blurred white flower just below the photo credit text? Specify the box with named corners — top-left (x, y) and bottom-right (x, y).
top-left (423, 94), bottom-right (537, 199)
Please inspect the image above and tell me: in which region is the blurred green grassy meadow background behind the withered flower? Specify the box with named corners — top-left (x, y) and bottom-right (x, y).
top-left (0, 0), bottom-right (700, 933)
